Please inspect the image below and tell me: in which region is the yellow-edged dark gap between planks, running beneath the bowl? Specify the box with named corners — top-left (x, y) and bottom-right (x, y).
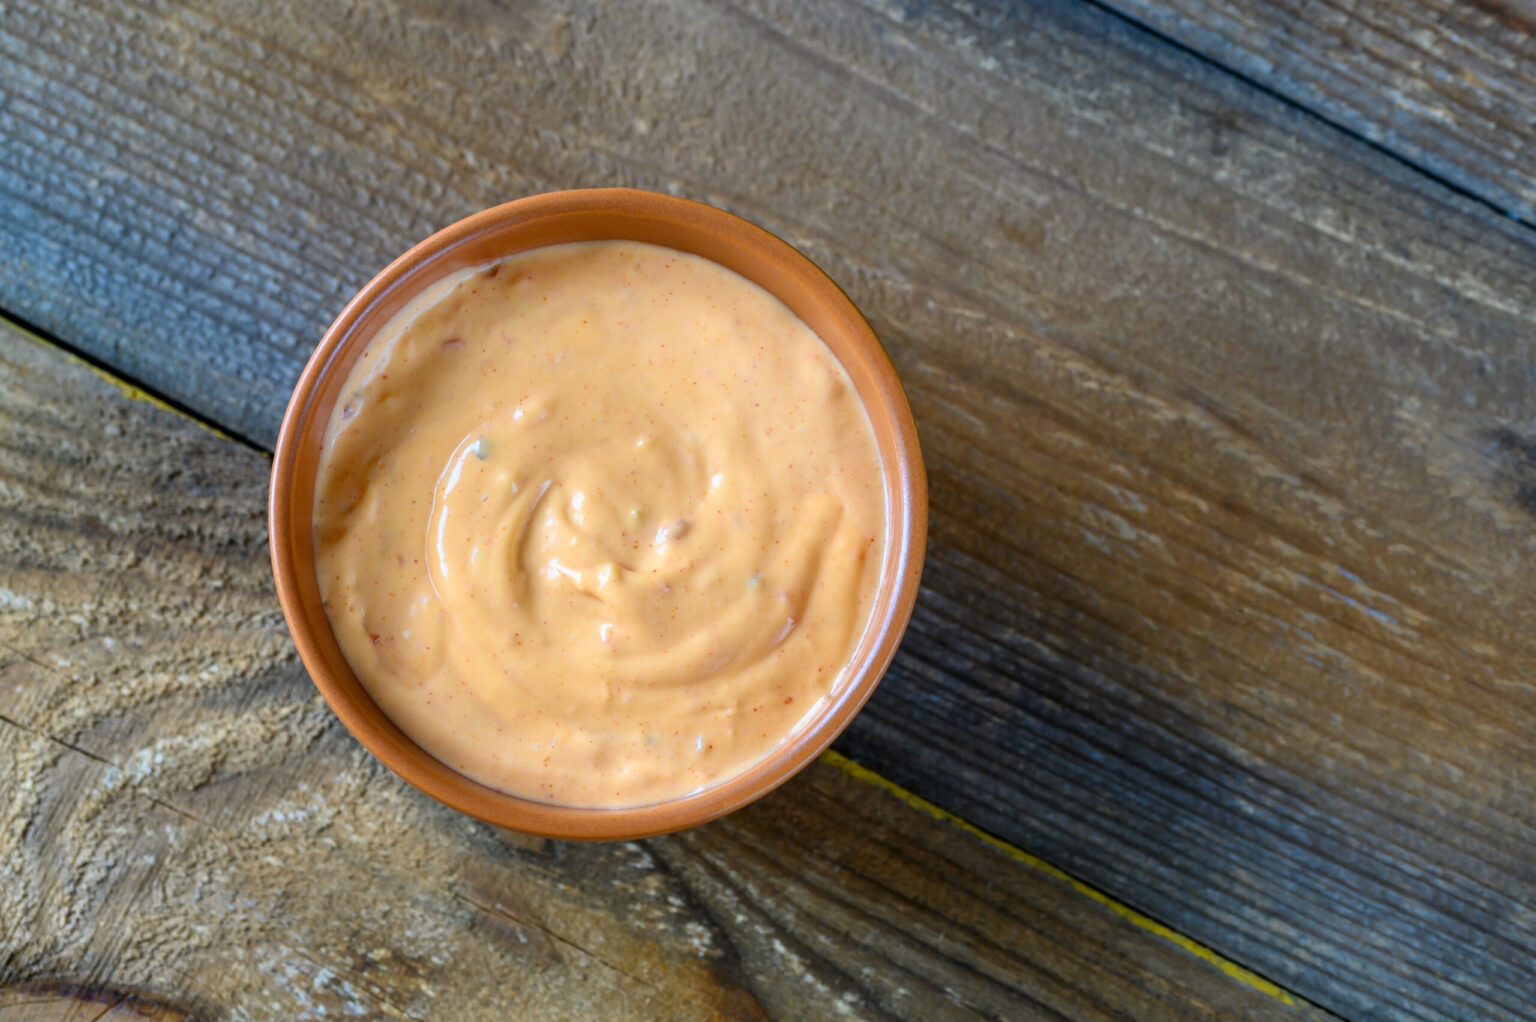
top-left (0, 309), bottom-right (1336, 1017)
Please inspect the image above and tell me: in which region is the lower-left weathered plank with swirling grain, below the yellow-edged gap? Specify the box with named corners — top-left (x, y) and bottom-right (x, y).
top-left (0, 327), bottom-right (1321, 1020)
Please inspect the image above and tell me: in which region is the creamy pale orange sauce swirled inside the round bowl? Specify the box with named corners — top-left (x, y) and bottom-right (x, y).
top-left (315, 241), bottom-right (886, 807)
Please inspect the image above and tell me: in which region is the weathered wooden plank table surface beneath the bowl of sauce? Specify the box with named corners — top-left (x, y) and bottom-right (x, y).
top-left (0, 0), bottom-right (1536, 1022)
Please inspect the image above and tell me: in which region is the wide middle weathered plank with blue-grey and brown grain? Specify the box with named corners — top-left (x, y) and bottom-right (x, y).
top-left (0, 0), bottom-right (1536, 1019)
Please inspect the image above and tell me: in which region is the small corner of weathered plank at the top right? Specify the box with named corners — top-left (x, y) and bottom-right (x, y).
top-left (1106, 0), bottom-right (1536, 226)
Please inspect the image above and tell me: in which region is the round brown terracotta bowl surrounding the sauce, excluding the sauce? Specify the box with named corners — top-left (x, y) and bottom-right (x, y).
top-left (270, 189), bottom-right (928, 839)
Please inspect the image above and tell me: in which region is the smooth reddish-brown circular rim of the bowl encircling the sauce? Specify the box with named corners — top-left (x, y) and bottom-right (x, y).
top-left (267, 187), bottom-right (928, 841)
